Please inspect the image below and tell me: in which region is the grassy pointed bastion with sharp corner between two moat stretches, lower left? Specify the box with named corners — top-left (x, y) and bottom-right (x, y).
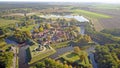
top-left (29, 45), bottom-right (56, 64)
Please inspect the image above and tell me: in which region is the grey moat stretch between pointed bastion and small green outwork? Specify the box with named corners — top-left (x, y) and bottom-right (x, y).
top-left (49, 46), bottom-right (74, 59)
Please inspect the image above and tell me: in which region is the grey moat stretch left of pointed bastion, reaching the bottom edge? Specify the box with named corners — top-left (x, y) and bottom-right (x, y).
top-left (19, 46), bottom-right (28, 68)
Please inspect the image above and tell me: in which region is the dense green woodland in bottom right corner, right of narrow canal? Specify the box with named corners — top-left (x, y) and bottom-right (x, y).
top-left (95, 45), bottom-right (119, 68)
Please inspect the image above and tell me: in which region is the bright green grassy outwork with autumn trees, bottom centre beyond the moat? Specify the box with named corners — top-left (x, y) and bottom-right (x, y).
top-left (60, 51), bottom-right (90, 65)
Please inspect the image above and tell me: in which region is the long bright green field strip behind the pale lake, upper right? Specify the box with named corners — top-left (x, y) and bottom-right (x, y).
top-left (72, 9), bottom-right (111, 18)
